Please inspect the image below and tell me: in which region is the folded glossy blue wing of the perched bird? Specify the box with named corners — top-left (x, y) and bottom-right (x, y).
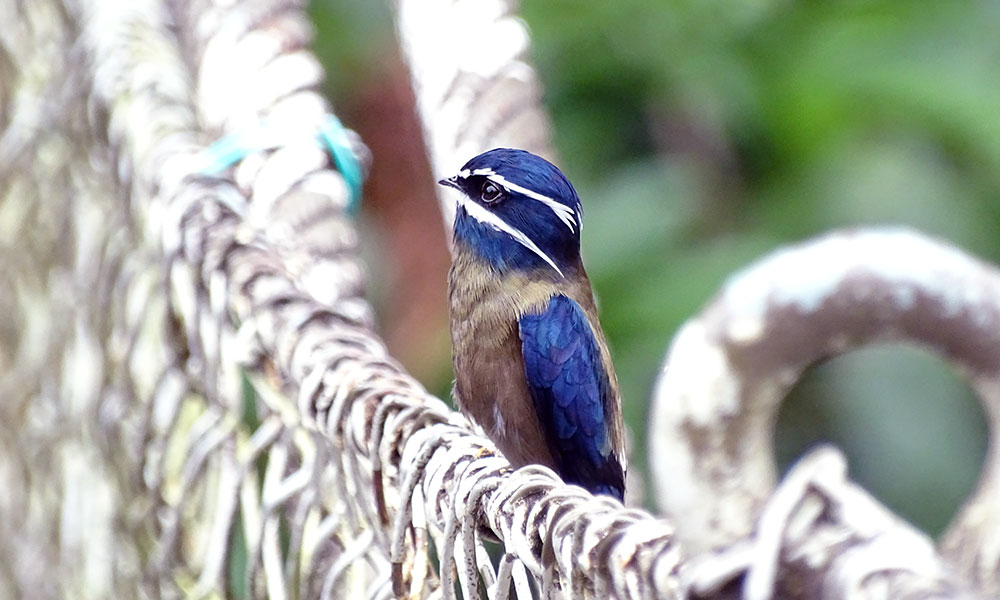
top-left (519, 295), bottom-right (625, 500)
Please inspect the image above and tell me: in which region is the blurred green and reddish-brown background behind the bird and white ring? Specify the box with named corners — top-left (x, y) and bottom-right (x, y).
top-left (311, 0), bottom-right (1000, 533)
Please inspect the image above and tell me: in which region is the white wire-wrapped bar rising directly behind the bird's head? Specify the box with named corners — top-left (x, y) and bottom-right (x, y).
top-left (395, 0), bottom-right (555, 228)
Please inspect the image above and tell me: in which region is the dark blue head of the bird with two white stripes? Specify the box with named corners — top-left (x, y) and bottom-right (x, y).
top-left (438, 148), bottom-right (583, 276)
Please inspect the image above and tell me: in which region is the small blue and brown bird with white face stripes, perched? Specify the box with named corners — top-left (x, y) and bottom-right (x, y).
top-left (438, 148), bottom-right (627, 501)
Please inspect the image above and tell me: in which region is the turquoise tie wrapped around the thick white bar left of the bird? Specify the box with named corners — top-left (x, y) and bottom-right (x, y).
top-left (202, 115), bottom-right (364, 215)
